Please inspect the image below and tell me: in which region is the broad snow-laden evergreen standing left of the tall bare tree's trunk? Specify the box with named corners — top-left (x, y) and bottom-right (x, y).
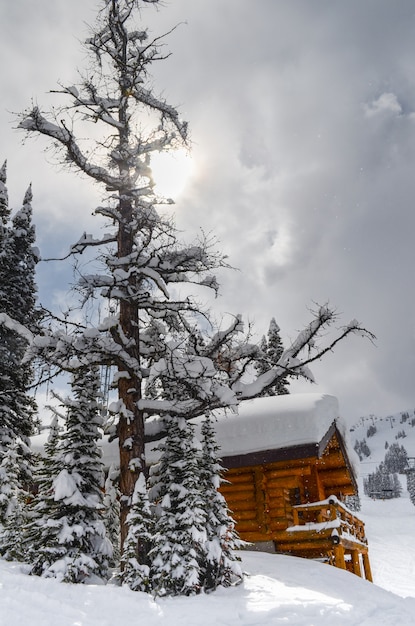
top-left (27, 368), bottom-right (111, 582)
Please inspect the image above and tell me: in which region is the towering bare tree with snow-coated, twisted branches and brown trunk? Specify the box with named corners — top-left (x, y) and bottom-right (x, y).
top-left (14, 0), bottom-right (376, 572)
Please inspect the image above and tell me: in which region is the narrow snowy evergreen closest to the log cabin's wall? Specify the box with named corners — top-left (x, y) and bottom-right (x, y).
top-left (199, 414), bottom-right (244, 591)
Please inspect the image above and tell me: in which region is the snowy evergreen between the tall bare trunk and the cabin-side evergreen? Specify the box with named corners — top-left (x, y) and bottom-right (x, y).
top-left (150, 416), bottom-right (207, 596)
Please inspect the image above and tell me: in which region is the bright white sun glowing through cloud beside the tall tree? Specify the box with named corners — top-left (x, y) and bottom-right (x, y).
top-left (151, 148), bottom-right (194, 199)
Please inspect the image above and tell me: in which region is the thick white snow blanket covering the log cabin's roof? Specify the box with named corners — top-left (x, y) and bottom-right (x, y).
top-left (32, 393), bottom-right (357, 474)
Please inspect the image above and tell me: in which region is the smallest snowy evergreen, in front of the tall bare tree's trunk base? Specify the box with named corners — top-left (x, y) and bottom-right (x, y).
top-left (121, 473), bottom-right (154, 591)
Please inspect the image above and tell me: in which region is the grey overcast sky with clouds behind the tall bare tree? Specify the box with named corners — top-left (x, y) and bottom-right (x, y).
top-left (0, 0), bottom-right (415, 422)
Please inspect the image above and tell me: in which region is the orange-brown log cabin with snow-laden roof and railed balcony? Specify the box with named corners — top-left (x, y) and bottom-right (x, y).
top-left (195, 394), bottom-right (372, 581)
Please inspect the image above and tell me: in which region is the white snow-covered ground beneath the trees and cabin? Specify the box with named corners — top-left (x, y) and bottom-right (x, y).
top-left (0, 494), bottom-right (415, 626)
